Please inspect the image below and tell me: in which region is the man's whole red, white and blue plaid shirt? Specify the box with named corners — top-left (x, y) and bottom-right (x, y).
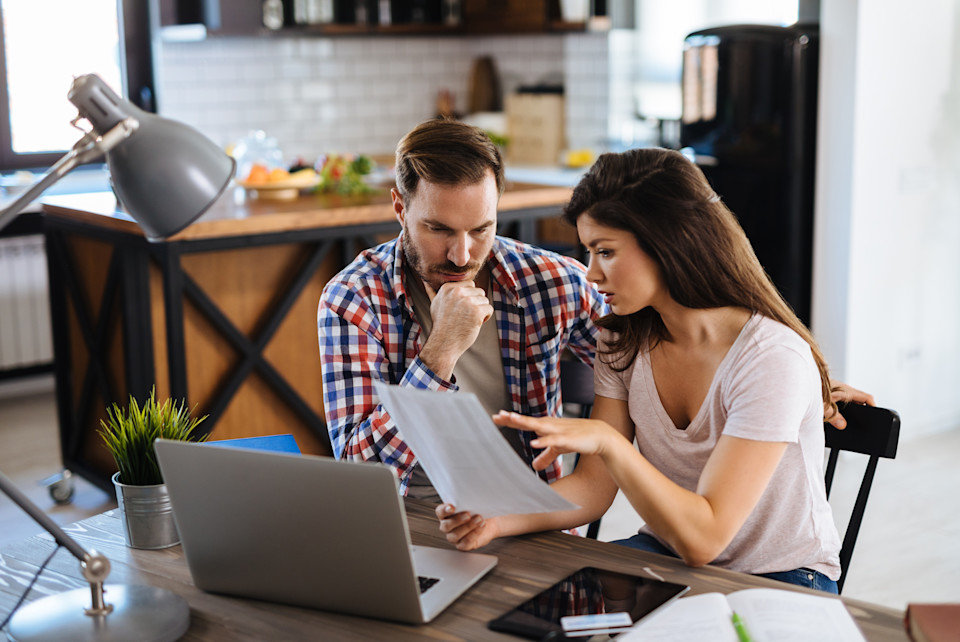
top-left (317, 236), bottom-right (607, 494)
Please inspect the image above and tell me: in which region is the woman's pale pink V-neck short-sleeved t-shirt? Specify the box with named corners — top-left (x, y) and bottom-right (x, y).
top-left (595, 314), bottom-right (840, 580)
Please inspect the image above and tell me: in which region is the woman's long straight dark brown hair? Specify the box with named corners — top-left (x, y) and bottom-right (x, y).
top-left (563, 148), bottom-right (836, 410)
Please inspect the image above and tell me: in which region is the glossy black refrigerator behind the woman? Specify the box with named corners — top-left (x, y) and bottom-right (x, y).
top-left (680, 24), bottom-right (819, 325)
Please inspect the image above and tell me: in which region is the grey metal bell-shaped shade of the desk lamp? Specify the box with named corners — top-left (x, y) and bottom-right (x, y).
top-left (68, 74), bottom-right (236, 240)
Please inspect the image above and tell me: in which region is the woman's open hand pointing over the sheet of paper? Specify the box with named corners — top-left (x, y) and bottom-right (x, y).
top-left (493, 410), bottom-right (625, 470)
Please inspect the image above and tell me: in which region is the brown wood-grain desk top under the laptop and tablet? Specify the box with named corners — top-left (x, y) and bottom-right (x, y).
top-left (0, 500), bottom-right (907, 642)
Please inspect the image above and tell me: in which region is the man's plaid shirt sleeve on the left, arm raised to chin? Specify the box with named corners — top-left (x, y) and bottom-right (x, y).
top-left (317, 272), bottom-right (456, 492)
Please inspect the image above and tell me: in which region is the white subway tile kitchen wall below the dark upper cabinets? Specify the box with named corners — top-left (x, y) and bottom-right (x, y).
top-left (158, 33), bottom-right (610, 161)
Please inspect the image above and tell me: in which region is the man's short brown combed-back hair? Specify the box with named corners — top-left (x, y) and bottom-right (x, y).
top-left (396, 118), bottom-right (504, 197)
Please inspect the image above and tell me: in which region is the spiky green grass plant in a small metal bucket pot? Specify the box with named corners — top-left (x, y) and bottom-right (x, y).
top-left (99, 390), bottom-right (206, 549)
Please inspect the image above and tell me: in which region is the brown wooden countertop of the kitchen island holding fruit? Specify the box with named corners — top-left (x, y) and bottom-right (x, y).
top-left (43, 183), bottom-right (573, 241)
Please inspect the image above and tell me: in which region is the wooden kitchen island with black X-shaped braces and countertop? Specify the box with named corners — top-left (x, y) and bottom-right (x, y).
top-left (43, 184), bottom-right (576, 491)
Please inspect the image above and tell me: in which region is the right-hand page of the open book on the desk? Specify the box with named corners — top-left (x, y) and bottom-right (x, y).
top-left (728, 589), bottom-right (865, 642)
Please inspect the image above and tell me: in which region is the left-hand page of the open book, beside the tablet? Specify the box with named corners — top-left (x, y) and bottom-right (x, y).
top-left (617, 593), bottom-right (740, 642)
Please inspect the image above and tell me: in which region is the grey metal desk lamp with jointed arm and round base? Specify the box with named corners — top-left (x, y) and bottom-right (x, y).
top-left (0, 75), bottom-right (236, 642)
